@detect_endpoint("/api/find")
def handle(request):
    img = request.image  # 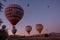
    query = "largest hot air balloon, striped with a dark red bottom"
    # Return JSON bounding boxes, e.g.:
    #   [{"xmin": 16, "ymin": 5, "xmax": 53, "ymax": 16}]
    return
[{"xmin": 5, "ymin": 4, "xmax": 24, "ymax": 25}]
